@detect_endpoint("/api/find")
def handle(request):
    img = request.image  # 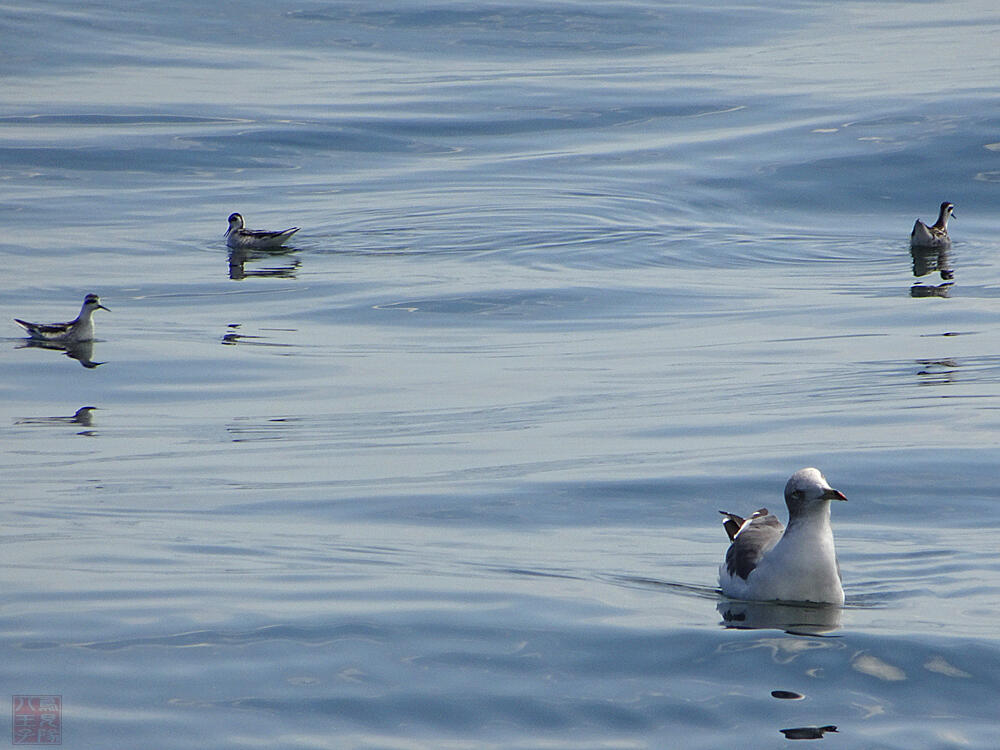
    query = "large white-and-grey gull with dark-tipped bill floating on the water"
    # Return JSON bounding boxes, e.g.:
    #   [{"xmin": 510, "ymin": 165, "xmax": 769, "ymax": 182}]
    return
[{"xmin": 719, "ymin": 469, "xmax": 847, "ymax": 604}]
